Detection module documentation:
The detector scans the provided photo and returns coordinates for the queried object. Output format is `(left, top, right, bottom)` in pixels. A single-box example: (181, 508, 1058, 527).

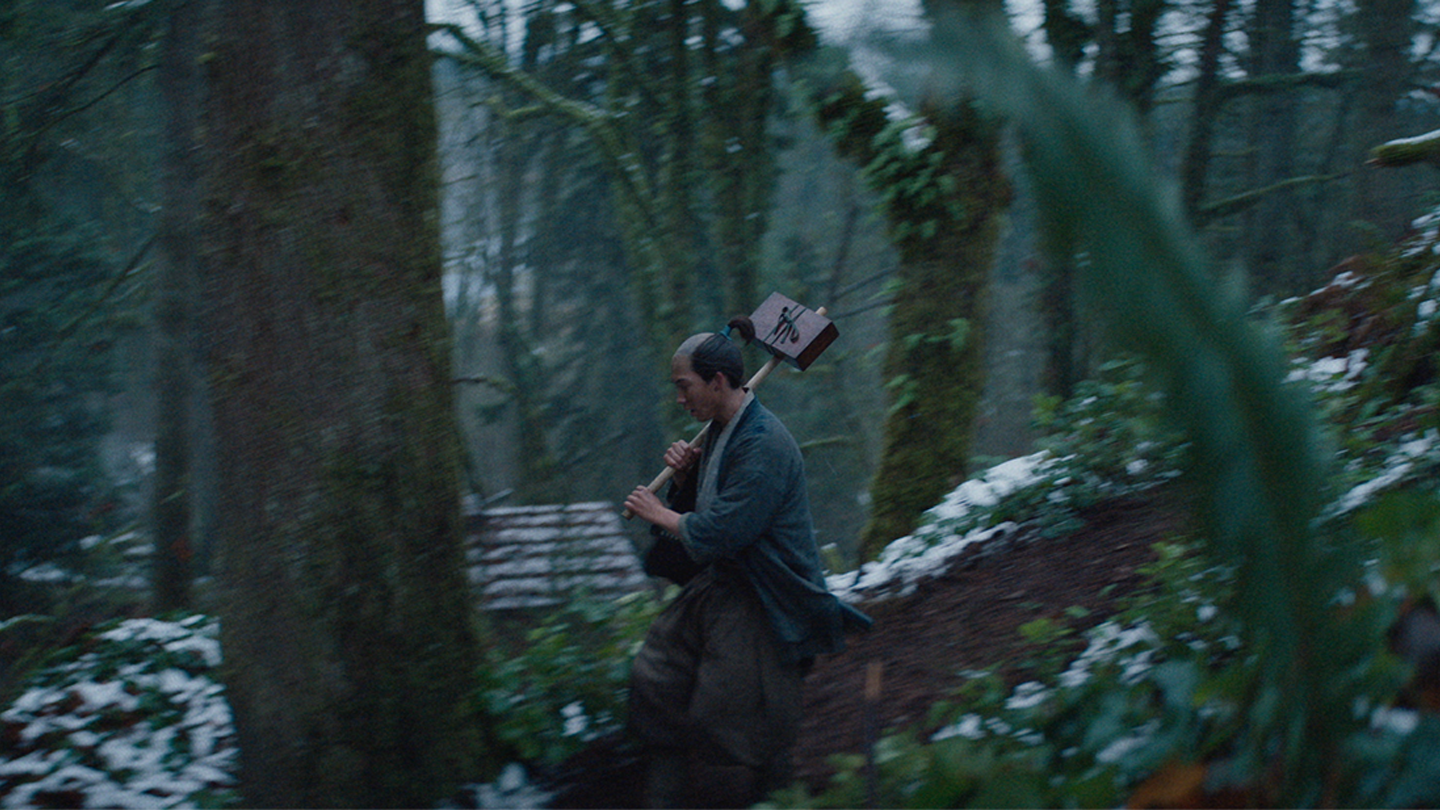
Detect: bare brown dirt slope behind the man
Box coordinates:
(541, 496, 1188, 807)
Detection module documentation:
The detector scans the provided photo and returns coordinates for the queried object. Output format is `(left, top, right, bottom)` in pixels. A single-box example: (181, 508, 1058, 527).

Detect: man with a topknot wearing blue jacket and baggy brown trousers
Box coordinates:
(625, 319, 870, 807)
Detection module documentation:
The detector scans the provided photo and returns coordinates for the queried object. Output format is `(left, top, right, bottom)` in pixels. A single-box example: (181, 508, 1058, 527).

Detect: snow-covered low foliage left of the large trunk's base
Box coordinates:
(0, 615, 236, 810)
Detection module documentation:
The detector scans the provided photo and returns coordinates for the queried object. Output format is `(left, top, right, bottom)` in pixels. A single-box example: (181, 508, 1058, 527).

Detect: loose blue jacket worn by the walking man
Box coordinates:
(665, 399, 871, 659)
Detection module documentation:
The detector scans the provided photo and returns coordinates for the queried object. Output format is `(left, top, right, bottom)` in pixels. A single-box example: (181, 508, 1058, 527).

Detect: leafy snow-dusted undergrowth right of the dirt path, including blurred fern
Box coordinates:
(775, 4, 1440, 807)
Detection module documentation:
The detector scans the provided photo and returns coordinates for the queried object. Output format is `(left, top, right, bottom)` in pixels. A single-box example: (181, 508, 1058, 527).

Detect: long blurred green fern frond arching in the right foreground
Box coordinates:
(915, 6, 1377, 804)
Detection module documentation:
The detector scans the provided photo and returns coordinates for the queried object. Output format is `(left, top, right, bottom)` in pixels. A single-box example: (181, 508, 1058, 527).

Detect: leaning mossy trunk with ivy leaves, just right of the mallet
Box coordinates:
(818, 22, 1009, 559)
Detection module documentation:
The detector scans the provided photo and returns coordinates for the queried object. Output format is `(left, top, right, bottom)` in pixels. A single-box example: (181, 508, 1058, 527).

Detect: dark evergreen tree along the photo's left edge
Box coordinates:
(0, 1, 151, 613)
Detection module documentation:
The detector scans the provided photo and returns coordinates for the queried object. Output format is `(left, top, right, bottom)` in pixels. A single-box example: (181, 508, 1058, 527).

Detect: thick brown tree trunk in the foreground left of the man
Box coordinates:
(202, 0, 482, 807)
